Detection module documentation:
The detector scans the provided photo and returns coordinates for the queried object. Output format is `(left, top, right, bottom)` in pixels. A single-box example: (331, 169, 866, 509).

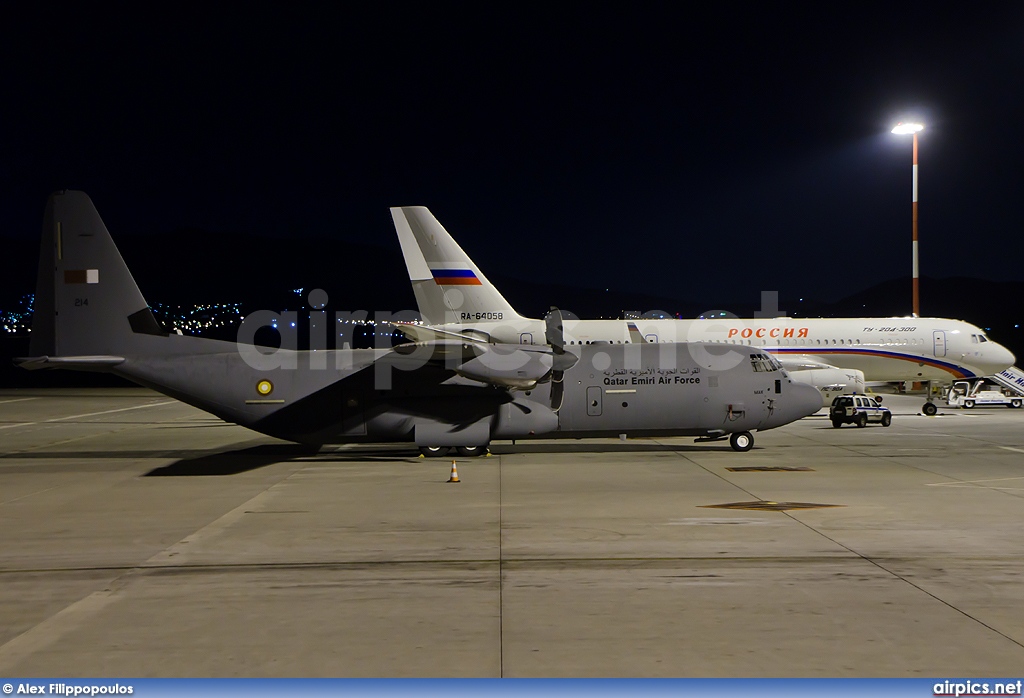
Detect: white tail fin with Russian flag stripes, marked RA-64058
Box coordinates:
(391, 206, 521, 324)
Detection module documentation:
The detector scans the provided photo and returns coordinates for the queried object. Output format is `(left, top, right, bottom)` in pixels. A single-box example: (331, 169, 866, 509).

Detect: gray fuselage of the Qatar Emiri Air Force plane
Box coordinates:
(102, 335, 821, 446)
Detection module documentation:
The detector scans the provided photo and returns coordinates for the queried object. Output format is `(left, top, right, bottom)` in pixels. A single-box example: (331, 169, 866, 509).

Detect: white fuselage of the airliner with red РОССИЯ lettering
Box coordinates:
(425, 317, 1015, 383)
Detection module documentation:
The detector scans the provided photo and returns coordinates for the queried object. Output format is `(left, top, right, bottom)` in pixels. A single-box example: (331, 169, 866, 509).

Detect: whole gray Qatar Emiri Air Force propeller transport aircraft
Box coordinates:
(15, 191, 821, 455)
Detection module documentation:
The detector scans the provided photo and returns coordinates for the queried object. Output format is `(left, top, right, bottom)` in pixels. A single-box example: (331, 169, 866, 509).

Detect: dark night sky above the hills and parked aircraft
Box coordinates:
(6, 3, 1024, 304)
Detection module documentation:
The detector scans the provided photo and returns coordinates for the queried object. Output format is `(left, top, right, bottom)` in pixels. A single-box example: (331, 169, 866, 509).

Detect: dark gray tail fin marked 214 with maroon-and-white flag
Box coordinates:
(30, 190, 165, 356)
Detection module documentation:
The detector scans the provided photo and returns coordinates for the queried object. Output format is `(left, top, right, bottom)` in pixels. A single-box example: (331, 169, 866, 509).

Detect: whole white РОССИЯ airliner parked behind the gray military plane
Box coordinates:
(391, 206, 1014, 415)
